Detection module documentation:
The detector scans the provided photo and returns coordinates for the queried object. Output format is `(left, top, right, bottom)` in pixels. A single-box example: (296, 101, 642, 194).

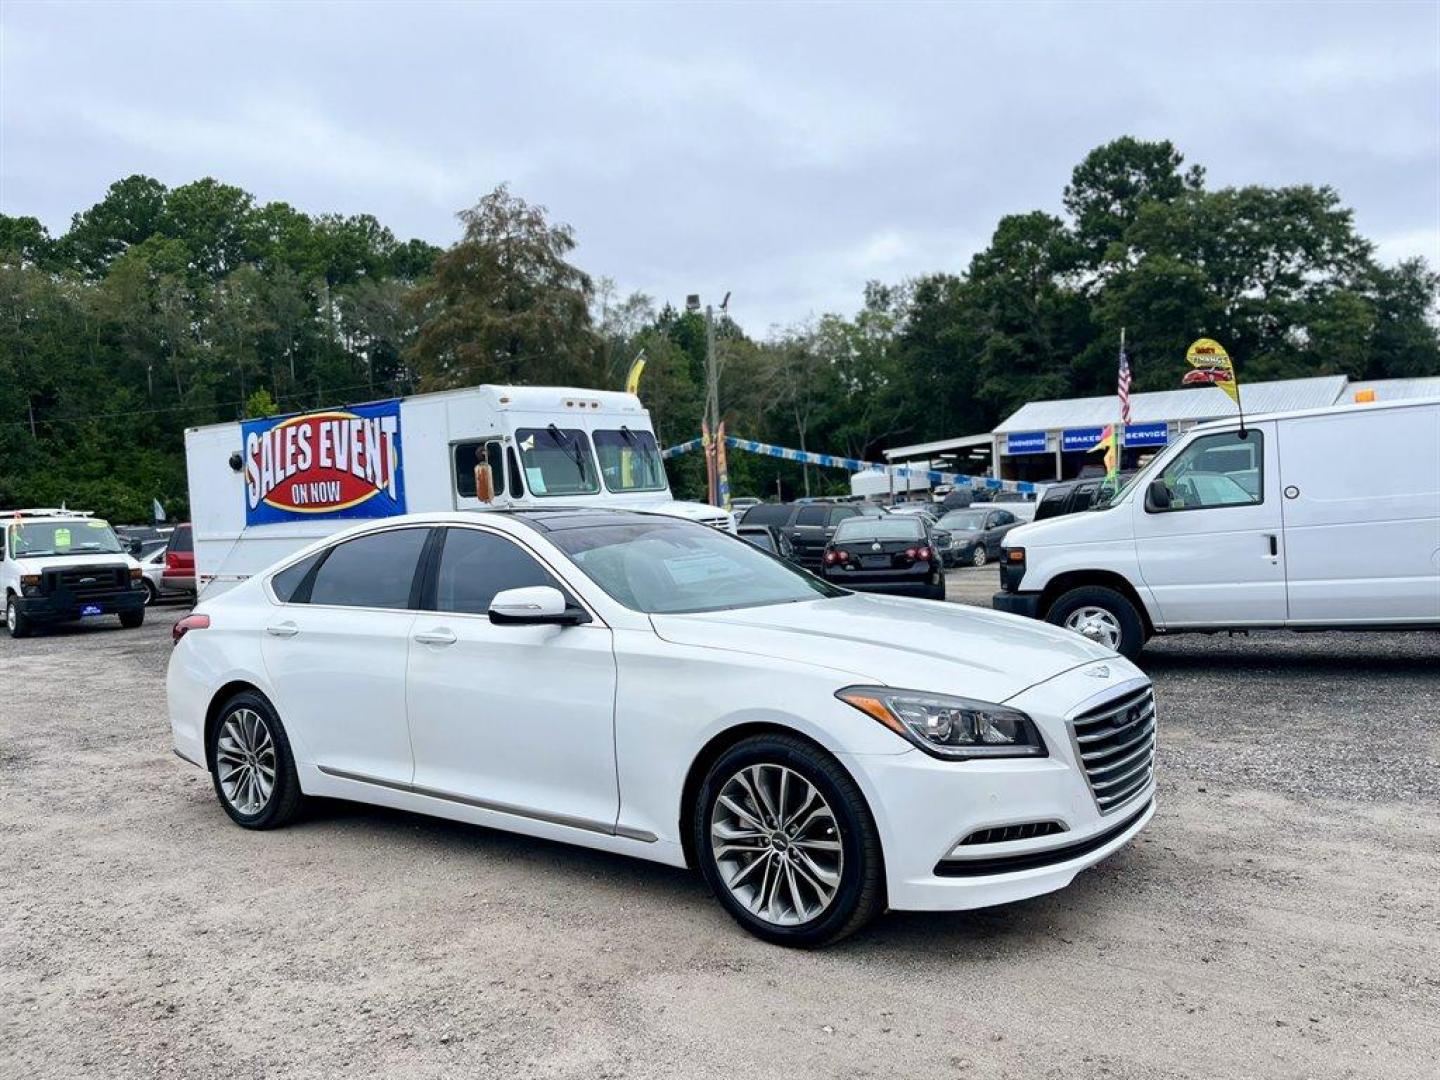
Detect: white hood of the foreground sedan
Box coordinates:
(651, 593, 1115, 701)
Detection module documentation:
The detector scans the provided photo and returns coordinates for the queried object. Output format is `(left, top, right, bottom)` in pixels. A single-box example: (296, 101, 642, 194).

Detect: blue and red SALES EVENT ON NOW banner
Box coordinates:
(240, 400, 405, 526)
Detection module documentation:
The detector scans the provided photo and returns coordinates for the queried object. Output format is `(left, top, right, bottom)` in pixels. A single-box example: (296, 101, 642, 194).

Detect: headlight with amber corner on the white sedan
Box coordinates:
(835, 687, 1045, 760)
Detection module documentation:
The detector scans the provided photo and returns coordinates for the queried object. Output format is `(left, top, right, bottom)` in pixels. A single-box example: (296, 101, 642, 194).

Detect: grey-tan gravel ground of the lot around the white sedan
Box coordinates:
(0, 570, 1440, 1080)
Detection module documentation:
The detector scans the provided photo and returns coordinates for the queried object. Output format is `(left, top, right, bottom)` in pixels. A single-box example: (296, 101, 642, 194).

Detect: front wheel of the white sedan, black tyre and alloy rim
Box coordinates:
(693, 734, 884, 948)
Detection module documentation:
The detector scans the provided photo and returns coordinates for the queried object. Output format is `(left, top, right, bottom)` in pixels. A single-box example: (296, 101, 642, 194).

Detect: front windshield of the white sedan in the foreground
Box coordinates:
(549, 521, 845, 615)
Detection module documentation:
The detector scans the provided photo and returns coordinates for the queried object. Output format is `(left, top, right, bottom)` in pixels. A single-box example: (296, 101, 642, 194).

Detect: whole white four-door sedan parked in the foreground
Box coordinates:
(168, 510, 1156, 945)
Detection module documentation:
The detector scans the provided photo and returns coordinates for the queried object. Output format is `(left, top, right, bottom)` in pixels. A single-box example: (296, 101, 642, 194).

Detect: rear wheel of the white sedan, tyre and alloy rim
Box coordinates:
(207, 691, 304, 829)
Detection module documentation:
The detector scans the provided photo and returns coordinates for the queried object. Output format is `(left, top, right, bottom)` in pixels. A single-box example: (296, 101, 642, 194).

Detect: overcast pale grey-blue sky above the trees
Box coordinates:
(0, 0, 1440, 334)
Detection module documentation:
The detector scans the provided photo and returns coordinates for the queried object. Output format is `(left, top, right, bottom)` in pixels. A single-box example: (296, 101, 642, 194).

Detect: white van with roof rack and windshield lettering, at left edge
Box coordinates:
(0, 510, 145, 638)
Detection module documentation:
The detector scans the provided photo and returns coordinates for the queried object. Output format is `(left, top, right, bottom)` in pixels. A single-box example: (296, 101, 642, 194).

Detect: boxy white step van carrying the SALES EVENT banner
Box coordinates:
(186, 386, 734, 598)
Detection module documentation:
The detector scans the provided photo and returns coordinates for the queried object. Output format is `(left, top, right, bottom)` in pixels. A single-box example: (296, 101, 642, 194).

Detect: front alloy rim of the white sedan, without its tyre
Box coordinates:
(710, 765, 844, 926)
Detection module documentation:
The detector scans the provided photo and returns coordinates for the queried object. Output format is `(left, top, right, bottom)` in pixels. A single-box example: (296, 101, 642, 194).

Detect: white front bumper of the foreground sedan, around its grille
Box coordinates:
(844, 661, 1155, 912)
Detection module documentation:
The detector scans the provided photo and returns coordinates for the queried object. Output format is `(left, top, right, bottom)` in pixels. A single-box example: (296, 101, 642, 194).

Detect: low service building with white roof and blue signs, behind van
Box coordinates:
(886, 374, 1440, 482)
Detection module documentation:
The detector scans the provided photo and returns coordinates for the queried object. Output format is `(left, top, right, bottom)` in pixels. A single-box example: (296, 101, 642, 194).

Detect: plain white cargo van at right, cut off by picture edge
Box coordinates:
(994, 399, 1440, 657)
